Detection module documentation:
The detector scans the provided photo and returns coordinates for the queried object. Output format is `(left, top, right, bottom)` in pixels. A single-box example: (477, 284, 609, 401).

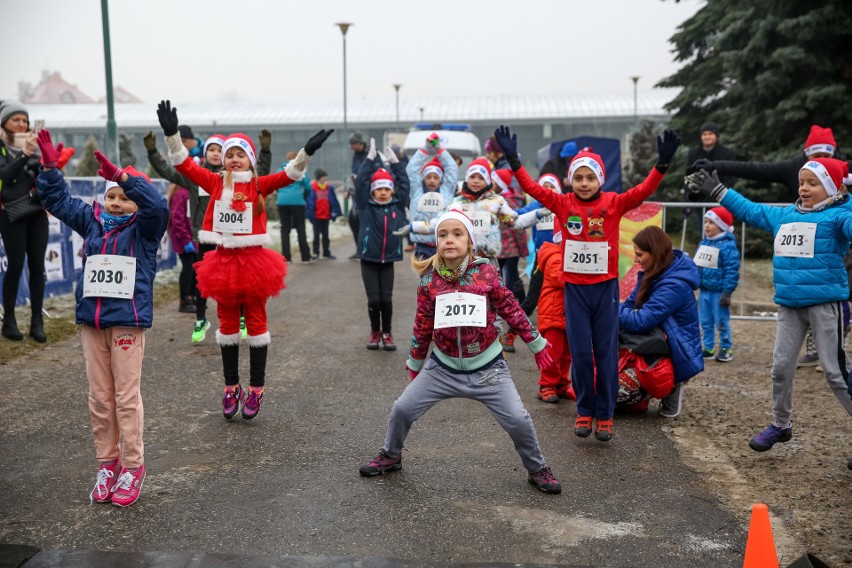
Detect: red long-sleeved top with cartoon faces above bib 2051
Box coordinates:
(515, 166, 663, 284)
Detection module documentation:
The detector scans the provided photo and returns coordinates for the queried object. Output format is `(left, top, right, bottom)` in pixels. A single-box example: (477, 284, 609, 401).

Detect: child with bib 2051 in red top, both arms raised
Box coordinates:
(494, 126, 680, 442)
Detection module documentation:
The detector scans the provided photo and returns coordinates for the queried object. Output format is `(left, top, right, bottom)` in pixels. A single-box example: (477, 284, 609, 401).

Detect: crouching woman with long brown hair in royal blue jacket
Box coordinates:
(618, 226, 704, 418)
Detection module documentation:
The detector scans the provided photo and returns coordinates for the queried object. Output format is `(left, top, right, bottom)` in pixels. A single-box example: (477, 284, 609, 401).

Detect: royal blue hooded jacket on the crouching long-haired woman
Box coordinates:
(618, 249, 704, 384)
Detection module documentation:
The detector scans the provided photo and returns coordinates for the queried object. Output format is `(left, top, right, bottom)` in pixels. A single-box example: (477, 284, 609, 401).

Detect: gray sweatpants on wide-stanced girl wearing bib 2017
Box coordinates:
(383, 357, 545, 472)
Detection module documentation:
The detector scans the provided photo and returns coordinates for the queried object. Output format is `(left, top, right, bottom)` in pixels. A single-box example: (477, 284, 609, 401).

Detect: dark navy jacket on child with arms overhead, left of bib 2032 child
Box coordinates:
(355, 156, 408, 263)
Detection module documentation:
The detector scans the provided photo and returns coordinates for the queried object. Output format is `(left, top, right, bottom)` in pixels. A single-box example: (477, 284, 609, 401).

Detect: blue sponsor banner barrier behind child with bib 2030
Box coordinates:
(0, 177, 177, 306)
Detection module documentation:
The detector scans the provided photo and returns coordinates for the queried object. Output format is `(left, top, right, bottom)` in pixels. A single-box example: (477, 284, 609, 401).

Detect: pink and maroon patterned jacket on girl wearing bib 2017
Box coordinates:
(407, 258, 547, 371)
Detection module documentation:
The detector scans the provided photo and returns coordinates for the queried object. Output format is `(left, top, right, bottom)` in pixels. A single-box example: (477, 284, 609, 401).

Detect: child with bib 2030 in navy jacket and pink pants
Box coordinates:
(36, 130, 169, 507)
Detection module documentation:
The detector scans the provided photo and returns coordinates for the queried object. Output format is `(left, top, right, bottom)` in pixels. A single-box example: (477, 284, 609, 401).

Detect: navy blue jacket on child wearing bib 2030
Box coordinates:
(36, 169, 169, 329)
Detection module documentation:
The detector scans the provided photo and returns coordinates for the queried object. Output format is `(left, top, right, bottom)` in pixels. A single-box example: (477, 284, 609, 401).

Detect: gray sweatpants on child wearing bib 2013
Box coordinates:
(772, 302, 852, 428)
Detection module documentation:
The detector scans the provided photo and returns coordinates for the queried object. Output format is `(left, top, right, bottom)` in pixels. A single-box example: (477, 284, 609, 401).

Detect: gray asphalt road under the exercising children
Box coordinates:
(0, 240, 747, 567)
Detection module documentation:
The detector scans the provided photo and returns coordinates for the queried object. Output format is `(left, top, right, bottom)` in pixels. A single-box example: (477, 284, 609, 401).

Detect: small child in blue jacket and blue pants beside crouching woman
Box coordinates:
(693, 207, 740, 363)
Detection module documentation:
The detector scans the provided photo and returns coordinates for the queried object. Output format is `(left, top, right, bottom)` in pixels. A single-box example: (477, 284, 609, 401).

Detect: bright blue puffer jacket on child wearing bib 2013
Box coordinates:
(722, 189, 852, 308)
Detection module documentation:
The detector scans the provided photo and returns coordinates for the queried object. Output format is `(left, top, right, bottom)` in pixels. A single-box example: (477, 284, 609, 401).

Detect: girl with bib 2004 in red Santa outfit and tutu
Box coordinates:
(157, 101, 334, 420)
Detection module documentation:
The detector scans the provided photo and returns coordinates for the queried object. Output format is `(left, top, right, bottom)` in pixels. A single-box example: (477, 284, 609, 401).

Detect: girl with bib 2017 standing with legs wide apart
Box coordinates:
(360, 211, 562, 493)
